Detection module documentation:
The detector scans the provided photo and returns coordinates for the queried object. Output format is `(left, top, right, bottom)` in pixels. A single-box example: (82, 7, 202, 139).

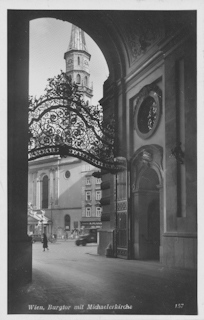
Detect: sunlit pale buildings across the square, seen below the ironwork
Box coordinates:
(28, 156, 101, 238)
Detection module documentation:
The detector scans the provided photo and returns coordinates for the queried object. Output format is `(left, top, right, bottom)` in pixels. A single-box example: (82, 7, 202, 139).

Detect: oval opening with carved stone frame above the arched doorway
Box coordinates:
(134, 85, 161, 139)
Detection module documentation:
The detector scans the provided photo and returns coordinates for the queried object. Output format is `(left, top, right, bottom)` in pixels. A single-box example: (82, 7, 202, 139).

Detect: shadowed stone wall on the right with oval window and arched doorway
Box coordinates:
(98, 12, 197, 269)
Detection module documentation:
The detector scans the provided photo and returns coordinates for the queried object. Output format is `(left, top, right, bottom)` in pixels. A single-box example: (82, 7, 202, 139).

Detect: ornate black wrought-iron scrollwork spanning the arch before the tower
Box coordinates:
(28, 72, 122, 172)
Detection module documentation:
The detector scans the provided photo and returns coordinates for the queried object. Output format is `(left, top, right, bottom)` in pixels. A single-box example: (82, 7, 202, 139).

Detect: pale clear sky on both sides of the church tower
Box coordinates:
(29, 18, 109, 105)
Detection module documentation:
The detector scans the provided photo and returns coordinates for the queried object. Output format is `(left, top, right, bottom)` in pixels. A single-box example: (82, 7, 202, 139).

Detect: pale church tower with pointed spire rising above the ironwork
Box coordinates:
(64, 25, 93, 104)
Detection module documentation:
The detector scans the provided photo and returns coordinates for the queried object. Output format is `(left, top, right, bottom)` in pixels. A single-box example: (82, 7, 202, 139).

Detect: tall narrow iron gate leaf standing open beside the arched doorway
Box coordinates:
(115, 157, 129, 259)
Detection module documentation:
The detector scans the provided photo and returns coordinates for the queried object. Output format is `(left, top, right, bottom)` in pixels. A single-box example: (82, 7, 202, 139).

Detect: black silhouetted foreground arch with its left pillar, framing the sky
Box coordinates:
(8, 10, 125, 288)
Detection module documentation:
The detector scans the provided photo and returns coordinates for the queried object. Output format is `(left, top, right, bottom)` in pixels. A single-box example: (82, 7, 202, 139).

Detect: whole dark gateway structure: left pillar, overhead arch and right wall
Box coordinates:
(8, 10, 197, 292)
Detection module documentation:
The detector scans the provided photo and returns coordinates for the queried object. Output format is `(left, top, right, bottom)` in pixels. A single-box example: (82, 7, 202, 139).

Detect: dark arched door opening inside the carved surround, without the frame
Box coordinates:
(132, 166, 160, 261)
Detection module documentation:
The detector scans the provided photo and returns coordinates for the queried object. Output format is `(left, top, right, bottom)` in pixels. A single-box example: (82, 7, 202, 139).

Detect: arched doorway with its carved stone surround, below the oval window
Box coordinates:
(131, 145, 163, 261)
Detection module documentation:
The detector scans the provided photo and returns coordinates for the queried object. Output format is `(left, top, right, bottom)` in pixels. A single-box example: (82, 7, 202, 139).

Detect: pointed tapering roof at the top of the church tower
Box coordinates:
(68, 24, 88, 52)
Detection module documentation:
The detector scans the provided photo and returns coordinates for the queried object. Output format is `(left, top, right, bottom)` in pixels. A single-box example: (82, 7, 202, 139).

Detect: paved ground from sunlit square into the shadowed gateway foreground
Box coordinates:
(9, 240, 197, 315)
